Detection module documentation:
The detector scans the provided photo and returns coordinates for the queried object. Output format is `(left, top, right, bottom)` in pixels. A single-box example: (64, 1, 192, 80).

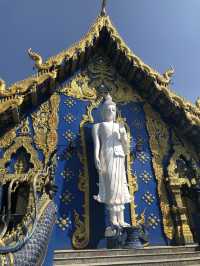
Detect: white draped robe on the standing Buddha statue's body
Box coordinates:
(96, 122, 131, 211)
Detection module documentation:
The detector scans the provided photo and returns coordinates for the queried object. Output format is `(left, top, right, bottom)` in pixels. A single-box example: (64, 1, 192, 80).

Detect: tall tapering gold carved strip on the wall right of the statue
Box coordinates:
(144, 103, 174, 239)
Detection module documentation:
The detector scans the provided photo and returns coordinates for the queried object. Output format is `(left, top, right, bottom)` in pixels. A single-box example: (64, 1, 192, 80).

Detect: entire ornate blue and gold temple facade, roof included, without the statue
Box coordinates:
(0, 4, 200, 266)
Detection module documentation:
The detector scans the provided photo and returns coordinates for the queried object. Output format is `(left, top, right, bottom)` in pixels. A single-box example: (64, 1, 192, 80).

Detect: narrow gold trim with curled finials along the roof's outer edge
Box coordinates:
(0, 16, 200, 135)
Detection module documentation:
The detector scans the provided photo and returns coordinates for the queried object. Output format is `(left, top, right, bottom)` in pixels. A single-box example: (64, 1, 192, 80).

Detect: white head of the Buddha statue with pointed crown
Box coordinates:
(102, 94, 117, 122)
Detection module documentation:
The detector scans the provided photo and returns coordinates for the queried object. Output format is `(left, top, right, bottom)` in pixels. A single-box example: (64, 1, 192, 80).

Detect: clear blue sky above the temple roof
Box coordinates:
(0, 0, 200, 102)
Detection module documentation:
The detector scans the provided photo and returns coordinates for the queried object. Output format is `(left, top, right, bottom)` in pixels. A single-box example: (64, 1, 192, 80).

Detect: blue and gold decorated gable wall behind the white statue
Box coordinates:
(0, 55, 198, 265)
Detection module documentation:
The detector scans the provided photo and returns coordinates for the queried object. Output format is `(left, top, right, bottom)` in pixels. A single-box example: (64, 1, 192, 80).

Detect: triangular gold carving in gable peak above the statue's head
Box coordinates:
(60, 55, 142, 103)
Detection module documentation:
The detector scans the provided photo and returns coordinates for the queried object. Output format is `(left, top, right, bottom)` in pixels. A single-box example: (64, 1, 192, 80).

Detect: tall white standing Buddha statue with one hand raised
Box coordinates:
(93, 94, 131, 227)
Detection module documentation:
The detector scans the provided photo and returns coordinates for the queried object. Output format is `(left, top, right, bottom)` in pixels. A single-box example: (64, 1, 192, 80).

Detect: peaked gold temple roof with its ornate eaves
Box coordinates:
(0, 15, 200, 141)
